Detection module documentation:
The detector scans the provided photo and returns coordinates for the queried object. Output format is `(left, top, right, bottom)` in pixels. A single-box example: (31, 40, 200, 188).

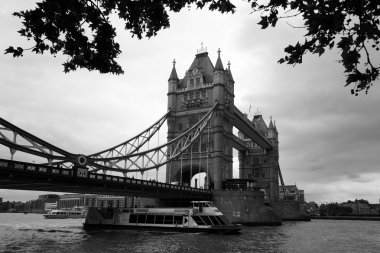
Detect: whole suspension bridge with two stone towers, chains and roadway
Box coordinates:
(0, 46, 296, 223)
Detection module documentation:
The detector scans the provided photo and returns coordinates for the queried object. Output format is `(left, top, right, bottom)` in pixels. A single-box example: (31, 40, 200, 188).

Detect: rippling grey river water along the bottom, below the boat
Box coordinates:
(0, 213, 380, 253)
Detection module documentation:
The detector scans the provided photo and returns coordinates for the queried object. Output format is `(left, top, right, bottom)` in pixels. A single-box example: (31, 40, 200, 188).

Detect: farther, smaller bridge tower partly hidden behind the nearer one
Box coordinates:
(239, 111, 280, 202)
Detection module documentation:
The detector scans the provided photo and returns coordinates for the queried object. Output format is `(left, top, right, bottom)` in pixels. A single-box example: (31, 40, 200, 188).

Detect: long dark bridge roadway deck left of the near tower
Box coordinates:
(0, 159, 212, 200)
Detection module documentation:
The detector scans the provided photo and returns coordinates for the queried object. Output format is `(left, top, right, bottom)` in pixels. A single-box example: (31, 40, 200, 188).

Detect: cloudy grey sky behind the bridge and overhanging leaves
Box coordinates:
(0, 0, 380, 203)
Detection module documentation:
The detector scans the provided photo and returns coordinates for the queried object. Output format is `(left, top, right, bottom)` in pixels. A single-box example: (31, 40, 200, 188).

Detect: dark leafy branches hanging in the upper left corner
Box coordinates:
(5, 0, 234, 74)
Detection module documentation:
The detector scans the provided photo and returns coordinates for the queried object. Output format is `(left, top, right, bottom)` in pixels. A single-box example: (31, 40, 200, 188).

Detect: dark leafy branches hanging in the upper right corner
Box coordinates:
(251, 0, 380, 95)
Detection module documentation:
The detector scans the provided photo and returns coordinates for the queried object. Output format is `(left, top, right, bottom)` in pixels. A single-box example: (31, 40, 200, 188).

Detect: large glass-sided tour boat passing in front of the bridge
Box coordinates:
(84, 201, 241, 234)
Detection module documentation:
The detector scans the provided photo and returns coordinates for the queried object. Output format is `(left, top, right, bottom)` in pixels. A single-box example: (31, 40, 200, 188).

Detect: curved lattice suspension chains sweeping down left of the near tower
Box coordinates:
(0, 104, 217, 177)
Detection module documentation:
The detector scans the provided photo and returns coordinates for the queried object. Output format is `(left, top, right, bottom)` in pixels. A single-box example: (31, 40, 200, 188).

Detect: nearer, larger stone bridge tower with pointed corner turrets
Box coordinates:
(166, 45, 234, 190)
